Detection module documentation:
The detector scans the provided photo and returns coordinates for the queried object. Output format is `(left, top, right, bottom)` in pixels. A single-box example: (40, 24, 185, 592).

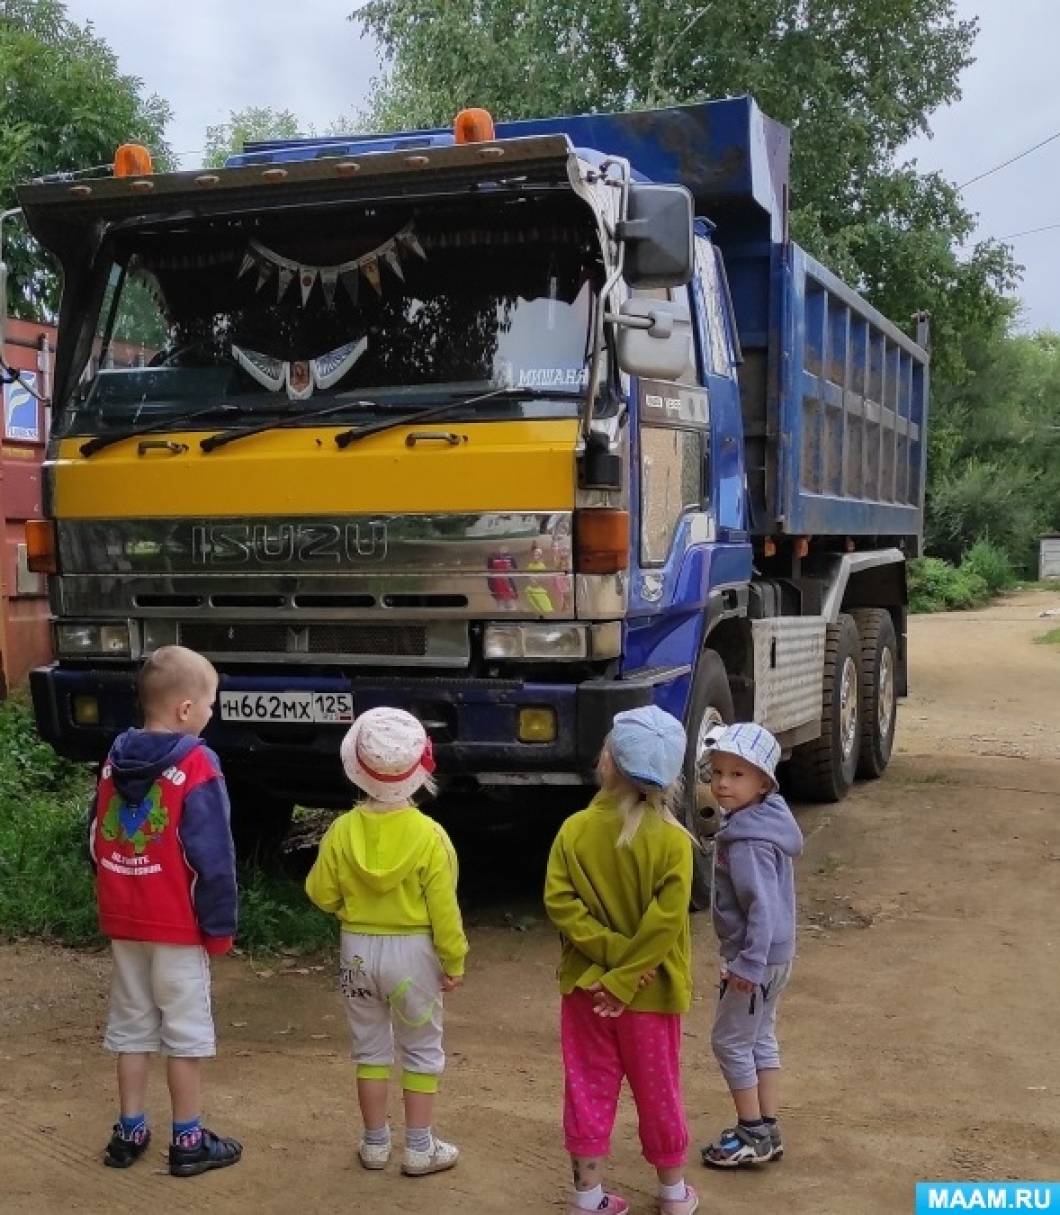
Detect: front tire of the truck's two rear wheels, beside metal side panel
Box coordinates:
(788, 612, 861, 802)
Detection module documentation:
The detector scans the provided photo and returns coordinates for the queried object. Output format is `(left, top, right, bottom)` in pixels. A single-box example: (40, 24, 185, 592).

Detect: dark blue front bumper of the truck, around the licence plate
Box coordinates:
(30, 663, 687, 804)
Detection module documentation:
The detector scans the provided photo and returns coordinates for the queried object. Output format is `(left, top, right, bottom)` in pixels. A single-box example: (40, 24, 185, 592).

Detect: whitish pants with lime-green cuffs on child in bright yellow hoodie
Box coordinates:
(339, 932, 445, 1092)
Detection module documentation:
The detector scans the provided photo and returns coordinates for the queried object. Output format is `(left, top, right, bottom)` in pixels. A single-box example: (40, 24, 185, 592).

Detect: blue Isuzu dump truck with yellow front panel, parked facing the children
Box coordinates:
(21, 97, 928, 897)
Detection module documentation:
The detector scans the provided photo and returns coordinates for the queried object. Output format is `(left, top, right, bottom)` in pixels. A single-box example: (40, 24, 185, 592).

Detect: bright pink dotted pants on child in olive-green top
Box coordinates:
(560, 991, 688, 1169)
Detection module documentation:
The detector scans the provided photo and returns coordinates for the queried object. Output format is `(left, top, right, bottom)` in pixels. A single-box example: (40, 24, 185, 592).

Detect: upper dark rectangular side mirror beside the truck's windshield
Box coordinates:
(618, 181, 693, 288)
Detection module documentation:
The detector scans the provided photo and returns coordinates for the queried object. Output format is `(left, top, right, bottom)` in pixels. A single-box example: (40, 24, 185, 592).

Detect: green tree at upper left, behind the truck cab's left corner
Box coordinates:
(0, 0, 170, 317)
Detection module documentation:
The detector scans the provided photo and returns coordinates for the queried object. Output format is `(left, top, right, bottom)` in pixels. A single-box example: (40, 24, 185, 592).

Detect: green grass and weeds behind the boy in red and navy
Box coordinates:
(0, 700, 338, 954)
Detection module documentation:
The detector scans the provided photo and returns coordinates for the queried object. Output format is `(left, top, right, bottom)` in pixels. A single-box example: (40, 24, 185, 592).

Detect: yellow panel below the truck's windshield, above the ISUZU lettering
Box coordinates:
(52, 419, 577, 519)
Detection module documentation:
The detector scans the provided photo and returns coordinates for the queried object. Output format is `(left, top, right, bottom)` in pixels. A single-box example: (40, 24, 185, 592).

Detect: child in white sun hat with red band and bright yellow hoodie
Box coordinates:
(305, 708, 468, 1176)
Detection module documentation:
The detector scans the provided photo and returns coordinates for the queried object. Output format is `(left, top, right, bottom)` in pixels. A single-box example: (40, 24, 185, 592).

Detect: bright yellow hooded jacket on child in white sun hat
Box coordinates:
(305, 806, 468, 977)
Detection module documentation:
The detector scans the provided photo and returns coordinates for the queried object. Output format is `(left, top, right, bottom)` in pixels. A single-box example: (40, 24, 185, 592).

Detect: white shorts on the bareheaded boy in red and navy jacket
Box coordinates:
(103, 940, 218, 1058)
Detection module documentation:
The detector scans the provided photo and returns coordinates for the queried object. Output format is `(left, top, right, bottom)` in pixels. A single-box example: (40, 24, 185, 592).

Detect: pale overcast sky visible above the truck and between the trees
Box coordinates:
(67, 0, 1060, 329)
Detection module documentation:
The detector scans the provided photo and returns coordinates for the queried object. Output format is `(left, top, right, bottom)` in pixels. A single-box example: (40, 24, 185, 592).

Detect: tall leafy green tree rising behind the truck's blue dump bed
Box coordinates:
(350, 0, 1016, 379)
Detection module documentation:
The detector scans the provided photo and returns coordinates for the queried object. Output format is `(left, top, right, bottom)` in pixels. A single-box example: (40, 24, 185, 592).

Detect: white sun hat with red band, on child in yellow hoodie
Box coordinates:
(339, 708, 434, 806)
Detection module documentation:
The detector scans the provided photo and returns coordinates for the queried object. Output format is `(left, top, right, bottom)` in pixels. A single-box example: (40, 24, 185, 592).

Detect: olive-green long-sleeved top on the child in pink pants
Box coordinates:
(545, 793, 692, 1012)
